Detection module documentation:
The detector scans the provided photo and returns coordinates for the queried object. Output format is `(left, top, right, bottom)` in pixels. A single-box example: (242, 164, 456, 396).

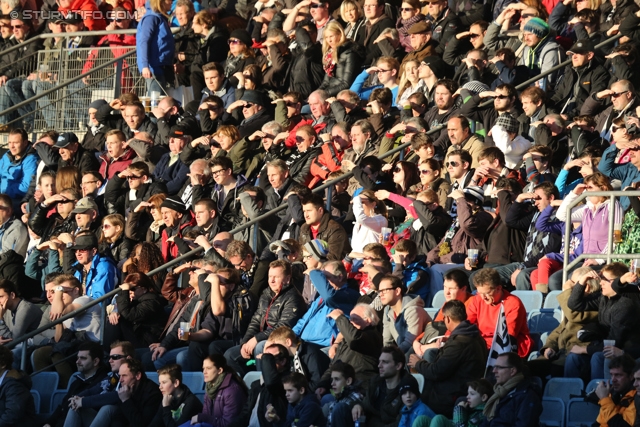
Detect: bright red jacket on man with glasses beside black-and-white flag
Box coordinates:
(466, 289, 533, 357)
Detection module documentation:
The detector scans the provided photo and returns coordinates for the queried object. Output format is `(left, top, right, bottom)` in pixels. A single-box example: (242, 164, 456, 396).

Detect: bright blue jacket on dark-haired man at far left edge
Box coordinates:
(0, 149, 38, 205)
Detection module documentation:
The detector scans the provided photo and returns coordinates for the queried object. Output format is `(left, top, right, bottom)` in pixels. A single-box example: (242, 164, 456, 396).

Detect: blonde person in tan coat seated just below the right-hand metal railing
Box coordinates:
(528, 267, 600, 378)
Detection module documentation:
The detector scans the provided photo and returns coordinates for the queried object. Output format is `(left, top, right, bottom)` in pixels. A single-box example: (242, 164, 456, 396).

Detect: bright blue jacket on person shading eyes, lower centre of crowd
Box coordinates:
(293, 270, 360, 347)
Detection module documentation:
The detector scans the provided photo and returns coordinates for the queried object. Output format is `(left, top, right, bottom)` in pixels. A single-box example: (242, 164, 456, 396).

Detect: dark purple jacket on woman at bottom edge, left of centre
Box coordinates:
(198, 374, 247, 427)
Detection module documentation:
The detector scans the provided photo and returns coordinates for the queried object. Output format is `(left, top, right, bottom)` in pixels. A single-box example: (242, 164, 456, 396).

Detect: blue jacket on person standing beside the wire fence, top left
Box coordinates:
(136, 1, 176, 76)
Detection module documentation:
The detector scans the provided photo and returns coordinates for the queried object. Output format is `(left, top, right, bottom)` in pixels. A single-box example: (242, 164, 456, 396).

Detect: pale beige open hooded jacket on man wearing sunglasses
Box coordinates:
(382, 295, 431, 353)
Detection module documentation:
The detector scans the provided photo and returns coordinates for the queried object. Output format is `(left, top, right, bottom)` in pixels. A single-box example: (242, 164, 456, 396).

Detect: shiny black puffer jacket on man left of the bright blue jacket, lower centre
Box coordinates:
(242, 284, 307, 344)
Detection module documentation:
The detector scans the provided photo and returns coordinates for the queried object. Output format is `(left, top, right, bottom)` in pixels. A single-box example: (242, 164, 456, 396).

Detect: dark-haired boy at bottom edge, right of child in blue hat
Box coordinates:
(415, 378, 493, 427)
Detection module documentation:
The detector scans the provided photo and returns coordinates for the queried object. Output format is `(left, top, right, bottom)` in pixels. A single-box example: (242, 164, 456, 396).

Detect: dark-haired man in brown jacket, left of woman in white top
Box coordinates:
(298, 194, 349, 260)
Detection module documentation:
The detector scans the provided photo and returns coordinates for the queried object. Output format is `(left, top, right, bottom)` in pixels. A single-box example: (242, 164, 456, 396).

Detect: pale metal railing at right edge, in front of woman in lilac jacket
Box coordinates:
(562, 191, 640, 283)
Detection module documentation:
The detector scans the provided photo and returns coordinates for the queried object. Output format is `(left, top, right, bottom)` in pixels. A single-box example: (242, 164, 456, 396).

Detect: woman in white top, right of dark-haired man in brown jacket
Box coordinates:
(351, 190, 388, 254)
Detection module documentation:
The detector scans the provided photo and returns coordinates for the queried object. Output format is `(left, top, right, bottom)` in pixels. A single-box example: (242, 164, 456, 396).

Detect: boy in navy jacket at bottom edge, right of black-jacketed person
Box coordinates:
(265, 372, 326, 427)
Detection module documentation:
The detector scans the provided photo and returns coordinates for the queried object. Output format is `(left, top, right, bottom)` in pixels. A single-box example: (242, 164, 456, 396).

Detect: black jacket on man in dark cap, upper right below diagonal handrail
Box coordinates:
(552, 61, 609, 119)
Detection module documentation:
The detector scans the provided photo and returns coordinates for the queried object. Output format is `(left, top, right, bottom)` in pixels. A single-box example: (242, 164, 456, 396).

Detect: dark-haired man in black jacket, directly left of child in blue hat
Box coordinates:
(351, 346, 411, 427)
